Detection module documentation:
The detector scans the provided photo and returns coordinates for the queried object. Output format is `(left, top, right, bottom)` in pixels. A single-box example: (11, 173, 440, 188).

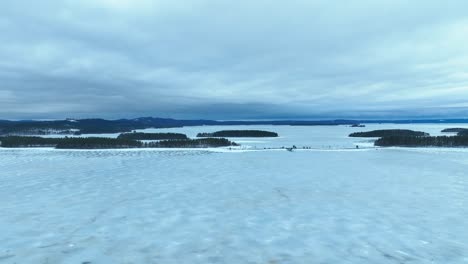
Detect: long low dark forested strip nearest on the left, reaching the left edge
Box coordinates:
(0, 136, 238, 149)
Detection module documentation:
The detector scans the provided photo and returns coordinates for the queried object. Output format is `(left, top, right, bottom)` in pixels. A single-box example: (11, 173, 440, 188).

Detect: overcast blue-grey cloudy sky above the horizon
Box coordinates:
(0, 0, 468, 119)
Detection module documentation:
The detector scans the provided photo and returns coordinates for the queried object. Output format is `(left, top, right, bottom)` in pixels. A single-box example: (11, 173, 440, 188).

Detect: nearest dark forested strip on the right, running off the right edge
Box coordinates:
(375, 136, 468, 147)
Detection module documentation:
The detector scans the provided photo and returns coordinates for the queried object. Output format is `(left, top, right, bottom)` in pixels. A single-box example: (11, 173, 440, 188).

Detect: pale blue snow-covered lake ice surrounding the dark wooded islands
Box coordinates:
(0, 125, 468, 264)
